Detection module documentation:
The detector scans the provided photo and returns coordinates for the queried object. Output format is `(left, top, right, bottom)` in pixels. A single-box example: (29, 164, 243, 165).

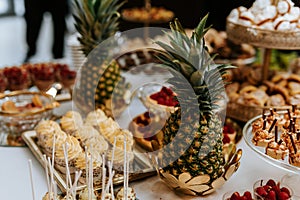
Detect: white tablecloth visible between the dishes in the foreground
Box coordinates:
(0, 102, 296, 200)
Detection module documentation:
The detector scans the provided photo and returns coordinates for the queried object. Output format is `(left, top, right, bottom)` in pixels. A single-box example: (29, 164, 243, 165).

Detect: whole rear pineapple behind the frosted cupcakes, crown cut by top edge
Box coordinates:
(73, 0, 129, 116)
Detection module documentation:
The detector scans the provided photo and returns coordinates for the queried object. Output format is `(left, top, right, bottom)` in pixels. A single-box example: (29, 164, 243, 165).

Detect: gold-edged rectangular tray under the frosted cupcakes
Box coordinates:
(22, 131, 156, 192)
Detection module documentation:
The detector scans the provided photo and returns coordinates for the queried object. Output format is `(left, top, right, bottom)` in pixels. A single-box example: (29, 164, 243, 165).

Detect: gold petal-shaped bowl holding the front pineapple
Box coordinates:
(151, 144, 242, 196)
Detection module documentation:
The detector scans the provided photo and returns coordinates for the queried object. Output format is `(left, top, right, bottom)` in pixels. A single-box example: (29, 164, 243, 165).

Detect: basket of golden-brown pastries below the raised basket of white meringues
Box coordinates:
(226, 66, 300, 122)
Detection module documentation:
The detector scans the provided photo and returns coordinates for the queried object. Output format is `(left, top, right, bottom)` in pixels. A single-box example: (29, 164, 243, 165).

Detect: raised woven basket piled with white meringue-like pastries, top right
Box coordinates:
(226, 0, 300, 49)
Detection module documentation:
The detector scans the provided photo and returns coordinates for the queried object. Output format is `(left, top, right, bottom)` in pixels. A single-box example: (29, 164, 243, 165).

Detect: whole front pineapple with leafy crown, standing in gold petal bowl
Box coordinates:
(152, 16, 232, 194)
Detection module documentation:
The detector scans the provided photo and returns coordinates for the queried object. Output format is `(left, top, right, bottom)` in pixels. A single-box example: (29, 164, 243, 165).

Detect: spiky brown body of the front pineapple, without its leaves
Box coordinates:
(161, 108, 224, 182)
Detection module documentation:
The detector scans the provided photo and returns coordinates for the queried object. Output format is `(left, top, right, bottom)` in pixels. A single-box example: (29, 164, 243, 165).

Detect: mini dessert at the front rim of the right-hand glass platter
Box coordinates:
(266, 140, 289, 160)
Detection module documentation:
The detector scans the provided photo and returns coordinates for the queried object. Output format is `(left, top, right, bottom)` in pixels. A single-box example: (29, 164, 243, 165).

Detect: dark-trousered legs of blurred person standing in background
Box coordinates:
(24, 0, 69, 62)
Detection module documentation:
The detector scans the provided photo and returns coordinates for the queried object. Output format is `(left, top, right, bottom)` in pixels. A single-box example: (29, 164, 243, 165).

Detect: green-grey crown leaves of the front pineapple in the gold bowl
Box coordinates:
(150, 15, 233, 115)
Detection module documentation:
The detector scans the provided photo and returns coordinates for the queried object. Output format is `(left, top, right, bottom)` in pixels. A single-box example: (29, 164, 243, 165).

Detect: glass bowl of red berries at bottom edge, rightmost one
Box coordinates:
(253, 179, 294, 200)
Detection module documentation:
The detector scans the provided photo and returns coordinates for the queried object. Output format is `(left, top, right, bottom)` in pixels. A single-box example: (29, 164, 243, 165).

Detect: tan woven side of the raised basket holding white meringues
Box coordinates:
(226, 20, 300, 50)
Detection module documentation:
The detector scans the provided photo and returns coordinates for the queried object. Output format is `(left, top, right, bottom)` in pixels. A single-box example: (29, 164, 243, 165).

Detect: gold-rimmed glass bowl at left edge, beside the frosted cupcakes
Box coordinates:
(0, 91, 59, 146)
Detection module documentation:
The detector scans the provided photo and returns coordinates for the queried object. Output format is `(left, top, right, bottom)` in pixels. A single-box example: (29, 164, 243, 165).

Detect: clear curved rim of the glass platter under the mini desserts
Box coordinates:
(243, 115, 300, 174)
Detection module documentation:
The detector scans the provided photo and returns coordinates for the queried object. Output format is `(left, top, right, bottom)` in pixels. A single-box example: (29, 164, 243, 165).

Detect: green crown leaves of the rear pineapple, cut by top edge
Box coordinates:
(73, 0, 125, 56)
